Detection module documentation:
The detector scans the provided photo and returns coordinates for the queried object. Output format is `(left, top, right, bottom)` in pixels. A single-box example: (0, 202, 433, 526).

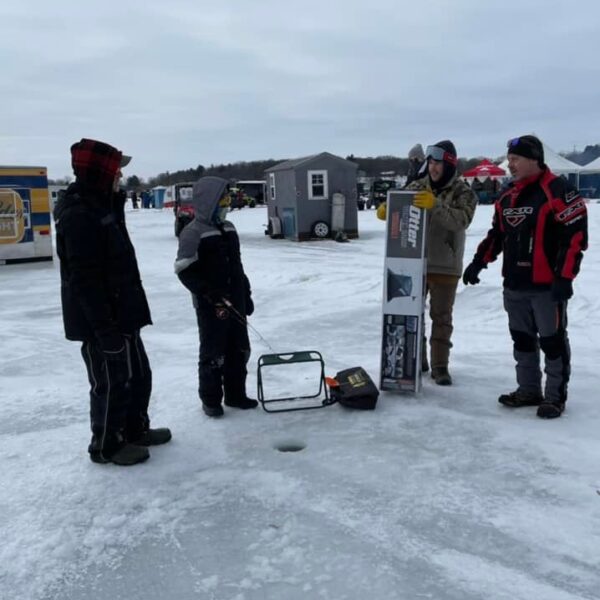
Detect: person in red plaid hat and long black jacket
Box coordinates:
(54, 138, 171, 465)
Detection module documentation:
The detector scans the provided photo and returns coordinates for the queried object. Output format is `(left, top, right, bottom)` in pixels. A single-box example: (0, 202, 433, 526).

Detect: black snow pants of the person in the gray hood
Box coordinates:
(196, 306, 250, 406)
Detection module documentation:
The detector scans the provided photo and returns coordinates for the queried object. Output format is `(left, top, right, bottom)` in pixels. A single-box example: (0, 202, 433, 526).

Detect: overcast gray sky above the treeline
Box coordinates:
(0, 0, 600, 178)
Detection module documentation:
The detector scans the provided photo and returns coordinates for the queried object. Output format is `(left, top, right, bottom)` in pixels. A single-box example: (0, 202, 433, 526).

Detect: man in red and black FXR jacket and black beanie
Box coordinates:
(463, 135, 587, 419)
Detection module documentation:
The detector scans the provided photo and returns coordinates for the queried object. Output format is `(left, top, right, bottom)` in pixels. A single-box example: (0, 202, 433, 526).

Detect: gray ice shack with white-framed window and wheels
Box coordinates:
(265, 152, 358, 241)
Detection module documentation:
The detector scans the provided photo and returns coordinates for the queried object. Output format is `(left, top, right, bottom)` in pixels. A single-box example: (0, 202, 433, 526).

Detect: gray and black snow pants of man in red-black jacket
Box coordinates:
(504, 288, 571, 402)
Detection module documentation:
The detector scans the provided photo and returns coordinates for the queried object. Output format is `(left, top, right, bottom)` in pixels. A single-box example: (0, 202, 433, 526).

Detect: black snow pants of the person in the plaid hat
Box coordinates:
(81, 331, 152, 450)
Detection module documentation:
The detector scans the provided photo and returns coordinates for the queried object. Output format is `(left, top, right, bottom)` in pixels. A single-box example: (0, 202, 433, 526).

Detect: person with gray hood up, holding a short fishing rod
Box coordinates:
(175, 177, 258, 417)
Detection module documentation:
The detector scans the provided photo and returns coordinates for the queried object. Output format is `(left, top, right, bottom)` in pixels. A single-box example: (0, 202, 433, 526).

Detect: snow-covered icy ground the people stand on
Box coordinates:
(0, 204, 600, 600)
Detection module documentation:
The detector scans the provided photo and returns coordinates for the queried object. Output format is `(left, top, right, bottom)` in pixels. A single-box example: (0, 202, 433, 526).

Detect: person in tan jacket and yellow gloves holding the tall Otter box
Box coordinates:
(377, 140, 477, 385)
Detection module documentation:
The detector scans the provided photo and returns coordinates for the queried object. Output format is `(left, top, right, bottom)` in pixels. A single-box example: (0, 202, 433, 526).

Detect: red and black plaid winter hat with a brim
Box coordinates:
(71, 138, 131, 191)
